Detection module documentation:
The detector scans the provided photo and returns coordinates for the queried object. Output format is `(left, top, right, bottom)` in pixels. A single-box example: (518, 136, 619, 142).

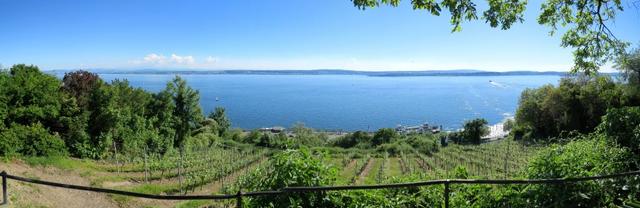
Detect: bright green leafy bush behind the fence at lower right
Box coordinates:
(521, 134, 638, 207)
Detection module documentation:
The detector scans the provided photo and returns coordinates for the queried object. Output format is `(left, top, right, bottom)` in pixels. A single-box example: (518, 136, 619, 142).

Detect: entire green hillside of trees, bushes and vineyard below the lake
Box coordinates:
(0, 57, 640, 207)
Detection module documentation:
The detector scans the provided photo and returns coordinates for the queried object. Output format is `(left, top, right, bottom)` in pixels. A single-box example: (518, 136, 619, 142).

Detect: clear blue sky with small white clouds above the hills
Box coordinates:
(0, 0, 640, 71)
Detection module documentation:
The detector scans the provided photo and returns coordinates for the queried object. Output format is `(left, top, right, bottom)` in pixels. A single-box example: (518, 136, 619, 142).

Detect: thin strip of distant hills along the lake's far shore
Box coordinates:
(49, 69, 600, 77)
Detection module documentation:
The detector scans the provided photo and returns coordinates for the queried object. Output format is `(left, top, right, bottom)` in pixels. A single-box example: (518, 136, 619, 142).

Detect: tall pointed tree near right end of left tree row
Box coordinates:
(167, 76, 202, 147)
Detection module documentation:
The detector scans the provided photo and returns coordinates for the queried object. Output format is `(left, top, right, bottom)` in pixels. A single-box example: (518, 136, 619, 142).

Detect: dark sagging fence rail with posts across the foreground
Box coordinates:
(0, 170, 640, 207)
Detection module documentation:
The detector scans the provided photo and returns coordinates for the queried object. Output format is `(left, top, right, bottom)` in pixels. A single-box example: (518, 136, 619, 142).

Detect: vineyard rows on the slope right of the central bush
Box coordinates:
(330, 141, 538, 185)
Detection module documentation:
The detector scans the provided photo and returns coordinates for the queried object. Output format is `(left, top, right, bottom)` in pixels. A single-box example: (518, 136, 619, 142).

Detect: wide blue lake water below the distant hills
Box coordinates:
(90, 74, 561, 131)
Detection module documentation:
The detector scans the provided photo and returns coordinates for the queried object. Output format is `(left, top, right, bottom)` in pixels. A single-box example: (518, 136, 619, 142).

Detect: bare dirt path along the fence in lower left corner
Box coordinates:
(0, 161, 118, 208)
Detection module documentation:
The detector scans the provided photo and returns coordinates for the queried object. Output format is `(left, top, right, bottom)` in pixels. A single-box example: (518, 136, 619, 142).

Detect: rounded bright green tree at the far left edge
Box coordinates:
(0, 64, 65, 156)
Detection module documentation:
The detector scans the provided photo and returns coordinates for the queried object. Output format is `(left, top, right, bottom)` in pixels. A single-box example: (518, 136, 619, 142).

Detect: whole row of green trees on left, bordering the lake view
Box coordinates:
(0, 64, 215, 159)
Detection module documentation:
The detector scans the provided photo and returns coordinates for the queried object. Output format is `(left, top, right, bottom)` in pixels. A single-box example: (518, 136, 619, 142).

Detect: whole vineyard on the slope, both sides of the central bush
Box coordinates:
(80, 140, 538, 207)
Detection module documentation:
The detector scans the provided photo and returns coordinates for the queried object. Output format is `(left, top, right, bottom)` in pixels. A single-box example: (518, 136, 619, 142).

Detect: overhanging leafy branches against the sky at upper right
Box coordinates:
(351, 0, 629, 74)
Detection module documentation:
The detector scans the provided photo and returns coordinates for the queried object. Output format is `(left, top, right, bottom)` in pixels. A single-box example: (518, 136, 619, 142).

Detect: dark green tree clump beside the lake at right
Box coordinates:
(513, 76, 637, 139)
